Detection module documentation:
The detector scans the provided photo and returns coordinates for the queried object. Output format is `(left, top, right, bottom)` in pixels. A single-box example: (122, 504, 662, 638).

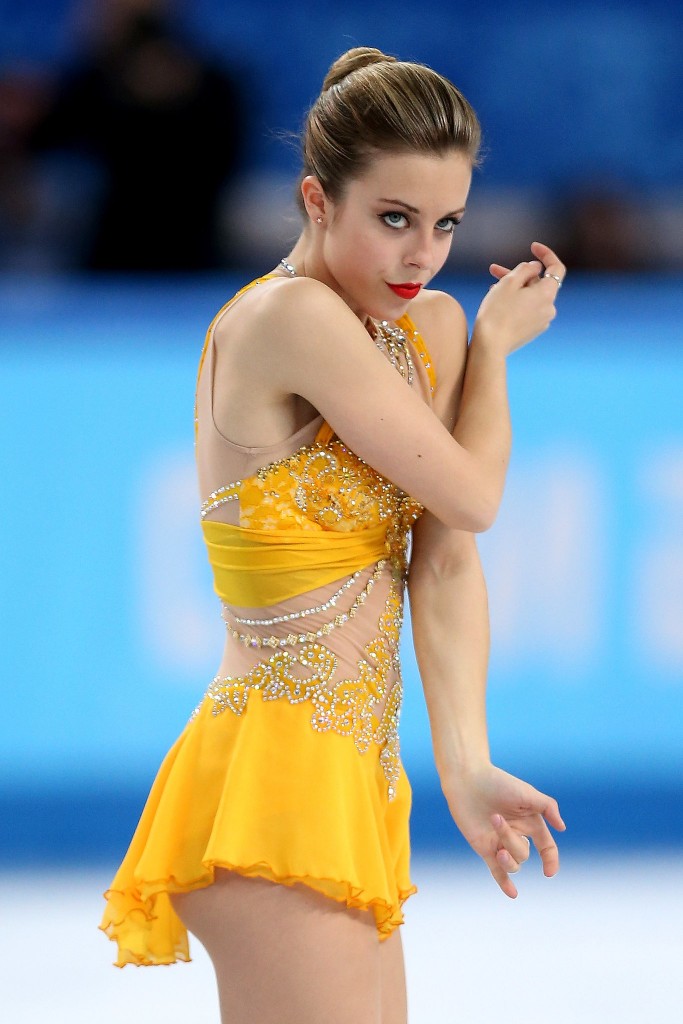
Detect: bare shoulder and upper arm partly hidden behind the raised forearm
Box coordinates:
(411, 289, 468, 425)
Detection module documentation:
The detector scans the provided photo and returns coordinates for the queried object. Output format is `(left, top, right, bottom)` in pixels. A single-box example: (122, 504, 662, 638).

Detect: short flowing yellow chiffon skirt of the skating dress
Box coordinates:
(100, 692, 416, 967)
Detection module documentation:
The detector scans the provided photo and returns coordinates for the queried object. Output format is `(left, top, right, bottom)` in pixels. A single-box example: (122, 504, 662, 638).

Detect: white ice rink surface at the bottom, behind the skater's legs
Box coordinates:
(0, 853, 683, 1024)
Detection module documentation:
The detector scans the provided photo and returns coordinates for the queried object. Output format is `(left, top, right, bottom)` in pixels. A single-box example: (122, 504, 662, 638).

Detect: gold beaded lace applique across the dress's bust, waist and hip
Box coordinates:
(198, 439, 422, 800)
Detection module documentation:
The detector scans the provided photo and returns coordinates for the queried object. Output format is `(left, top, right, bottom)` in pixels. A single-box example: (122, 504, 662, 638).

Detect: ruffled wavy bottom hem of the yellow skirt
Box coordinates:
(99, 860, 418, 968)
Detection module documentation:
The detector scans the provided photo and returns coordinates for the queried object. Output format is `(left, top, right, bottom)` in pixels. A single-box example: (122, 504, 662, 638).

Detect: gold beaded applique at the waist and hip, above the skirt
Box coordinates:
(195, 583, 402, 800)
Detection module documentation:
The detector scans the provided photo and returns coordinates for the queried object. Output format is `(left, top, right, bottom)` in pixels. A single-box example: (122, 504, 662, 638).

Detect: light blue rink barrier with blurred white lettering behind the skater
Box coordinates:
(0, 278, 683, 860)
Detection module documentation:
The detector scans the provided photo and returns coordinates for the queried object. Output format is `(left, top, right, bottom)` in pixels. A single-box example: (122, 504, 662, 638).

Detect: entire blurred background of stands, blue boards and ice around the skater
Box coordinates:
(0, 0, 683, 1024)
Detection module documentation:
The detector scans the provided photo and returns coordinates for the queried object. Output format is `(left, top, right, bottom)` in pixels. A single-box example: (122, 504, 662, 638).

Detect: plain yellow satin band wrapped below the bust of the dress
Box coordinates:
(202, 520, 387, 608)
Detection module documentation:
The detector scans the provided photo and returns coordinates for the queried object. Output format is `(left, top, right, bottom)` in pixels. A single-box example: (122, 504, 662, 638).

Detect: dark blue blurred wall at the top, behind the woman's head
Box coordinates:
(0, 0, 683, 195)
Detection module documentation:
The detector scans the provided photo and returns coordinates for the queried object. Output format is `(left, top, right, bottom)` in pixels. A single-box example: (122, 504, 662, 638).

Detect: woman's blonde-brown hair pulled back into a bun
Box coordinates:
(298, 46, 481, 210)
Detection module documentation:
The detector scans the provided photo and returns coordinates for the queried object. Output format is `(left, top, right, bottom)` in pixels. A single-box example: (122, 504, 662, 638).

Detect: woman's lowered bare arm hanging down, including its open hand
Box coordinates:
(409, 512, 564, 898)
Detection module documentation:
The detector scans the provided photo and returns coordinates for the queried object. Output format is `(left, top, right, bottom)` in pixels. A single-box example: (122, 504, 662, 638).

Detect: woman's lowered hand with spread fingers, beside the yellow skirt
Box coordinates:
(441, 764, 565, 899)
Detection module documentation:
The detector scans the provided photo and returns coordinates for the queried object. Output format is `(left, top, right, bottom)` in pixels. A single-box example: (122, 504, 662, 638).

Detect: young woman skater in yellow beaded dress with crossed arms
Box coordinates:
(102, 48, 564, 1024)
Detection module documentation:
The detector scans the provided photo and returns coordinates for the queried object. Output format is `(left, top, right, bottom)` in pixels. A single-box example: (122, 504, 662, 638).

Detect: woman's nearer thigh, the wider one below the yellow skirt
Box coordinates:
(172, 869, 385, 1024)
